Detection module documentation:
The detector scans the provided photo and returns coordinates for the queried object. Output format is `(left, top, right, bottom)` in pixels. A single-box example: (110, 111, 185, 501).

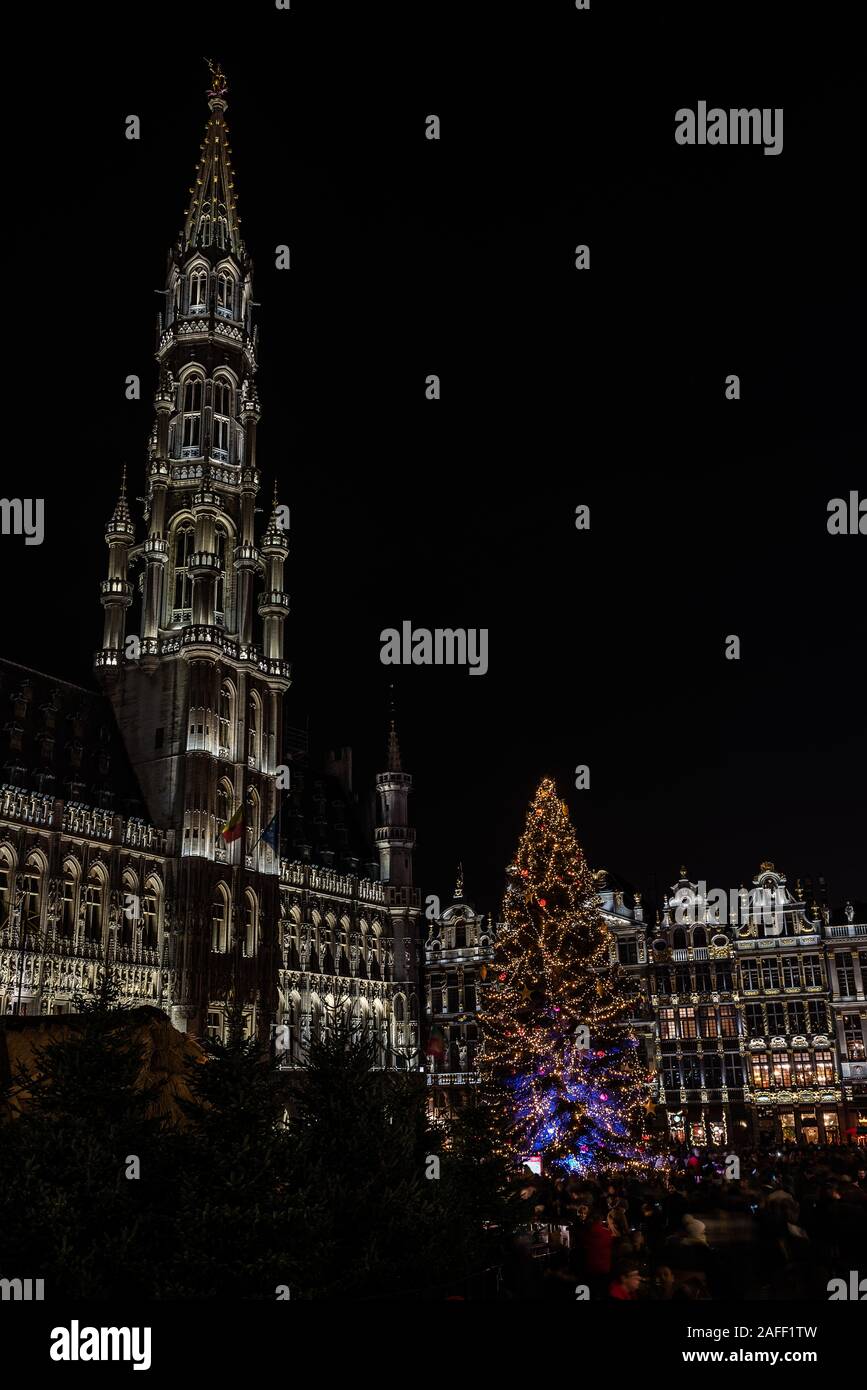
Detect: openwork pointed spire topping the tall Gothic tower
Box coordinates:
(181, 60, 243, 261)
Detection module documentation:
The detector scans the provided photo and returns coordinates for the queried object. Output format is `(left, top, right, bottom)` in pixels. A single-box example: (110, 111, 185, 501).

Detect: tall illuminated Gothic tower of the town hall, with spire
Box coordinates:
(96, 67, 290, 1034)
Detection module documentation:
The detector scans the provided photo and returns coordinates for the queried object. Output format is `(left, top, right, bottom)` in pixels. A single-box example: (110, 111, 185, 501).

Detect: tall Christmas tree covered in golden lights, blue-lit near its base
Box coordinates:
(481, 780, 647, 1172)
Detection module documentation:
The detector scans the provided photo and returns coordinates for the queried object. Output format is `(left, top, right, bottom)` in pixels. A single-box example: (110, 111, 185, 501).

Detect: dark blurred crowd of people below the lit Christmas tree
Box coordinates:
(506, 1144, 867, 1301)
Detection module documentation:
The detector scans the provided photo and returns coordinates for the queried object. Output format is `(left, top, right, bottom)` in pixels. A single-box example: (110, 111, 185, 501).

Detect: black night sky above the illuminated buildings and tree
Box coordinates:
(6, 0, 867, 909)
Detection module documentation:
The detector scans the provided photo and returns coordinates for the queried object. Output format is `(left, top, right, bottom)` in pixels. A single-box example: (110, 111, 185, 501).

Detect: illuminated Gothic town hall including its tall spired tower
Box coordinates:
(0, 68, 420, 1068)
